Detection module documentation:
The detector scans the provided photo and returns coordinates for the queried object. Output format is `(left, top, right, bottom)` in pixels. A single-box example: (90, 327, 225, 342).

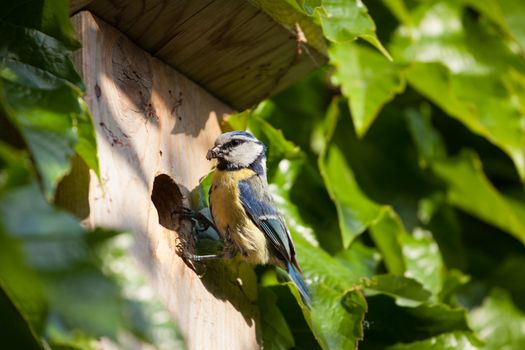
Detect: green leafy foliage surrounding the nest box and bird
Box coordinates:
(0, 0, 525, 350)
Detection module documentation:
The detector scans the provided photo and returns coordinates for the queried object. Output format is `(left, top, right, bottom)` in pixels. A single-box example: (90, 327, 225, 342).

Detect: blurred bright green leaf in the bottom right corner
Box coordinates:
(469, 288, 525, 350)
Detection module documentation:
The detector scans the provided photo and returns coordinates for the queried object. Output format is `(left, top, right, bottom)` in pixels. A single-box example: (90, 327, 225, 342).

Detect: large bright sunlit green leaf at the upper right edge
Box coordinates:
(391, 1, 525, 179)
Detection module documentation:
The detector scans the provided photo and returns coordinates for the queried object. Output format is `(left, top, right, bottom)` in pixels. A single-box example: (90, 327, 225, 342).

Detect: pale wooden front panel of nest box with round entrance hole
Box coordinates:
(73, 12, 260, 349)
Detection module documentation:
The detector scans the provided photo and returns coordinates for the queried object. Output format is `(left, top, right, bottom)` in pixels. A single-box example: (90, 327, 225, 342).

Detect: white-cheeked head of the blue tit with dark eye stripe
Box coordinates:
(206, 131, 266, 169)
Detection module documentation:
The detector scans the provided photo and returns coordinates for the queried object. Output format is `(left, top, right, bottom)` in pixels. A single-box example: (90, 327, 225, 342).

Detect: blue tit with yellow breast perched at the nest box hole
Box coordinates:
(206, 131, 311, 305)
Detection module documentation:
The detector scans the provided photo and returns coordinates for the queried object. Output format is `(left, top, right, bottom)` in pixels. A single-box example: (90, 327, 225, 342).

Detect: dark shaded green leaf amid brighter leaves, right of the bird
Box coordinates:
(340, 101, 440, 229)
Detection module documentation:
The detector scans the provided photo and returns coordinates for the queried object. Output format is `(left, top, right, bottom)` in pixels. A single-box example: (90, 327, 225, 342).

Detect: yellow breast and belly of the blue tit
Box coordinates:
(210, 169, 270, 264)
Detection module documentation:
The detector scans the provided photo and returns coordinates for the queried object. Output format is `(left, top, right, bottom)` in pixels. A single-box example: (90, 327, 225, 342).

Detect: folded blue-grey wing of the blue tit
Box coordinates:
(239, 175, 296, 264)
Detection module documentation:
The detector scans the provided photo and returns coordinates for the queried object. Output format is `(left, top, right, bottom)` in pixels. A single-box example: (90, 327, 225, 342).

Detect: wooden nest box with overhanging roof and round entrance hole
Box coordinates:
(66, 0, 326, 349)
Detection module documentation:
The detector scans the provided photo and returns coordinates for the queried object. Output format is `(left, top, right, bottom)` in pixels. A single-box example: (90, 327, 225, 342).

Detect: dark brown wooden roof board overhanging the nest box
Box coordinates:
(73, 0, 326, 109)
